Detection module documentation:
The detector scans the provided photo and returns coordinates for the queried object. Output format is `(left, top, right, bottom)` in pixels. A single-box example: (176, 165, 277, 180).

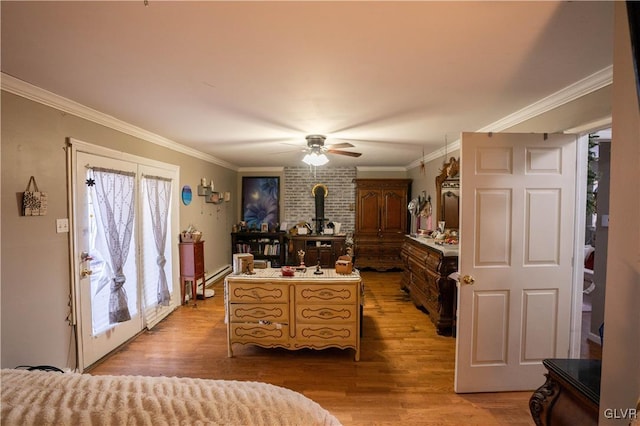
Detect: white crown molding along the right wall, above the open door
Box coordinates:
(406, 65, 613, 169)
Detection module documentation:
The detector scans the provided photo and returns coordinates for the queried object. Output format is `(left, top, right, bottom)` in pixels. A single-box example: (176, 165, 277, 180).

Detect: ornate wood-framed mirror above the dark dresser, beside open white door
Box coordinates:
(436, 157, 460, 229)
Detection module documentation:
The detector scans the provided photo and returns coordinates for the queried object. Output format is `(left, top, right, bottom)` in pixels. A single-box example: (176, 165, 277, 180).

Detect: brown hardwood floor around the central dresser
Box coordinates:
(90, 271, 532, 425)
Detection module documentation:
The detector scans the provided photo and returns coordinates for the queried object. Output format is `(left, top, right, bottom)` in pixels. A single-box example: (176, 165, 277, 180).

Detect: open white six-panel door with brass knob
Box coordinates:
(455, 133, 577, 393)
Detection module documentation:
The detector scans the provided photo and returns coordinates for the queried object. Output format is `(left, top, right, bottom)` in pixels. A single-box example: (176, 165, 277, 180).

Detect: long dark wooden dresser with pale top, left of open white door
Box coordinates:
(401, 236, 458, 335)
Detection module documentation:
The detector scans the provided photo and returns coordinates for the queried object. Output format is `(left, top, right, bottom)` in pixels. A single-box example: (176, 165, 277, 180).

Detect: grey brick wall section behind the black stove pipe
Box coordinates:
(281, 167, 356, 232)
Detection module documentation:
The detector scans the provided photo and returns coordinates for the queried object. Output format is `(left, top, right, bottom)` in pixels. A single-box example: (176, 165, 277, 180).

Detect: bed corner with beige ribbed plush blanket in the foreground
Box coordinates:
(0, 369, 340, 426)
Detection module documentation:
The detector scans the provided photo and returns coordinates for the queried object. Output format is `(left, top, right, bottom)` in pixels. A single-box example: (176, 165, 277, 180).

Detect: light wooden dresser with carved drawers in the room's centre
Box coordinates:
(224, 268, 362, 361)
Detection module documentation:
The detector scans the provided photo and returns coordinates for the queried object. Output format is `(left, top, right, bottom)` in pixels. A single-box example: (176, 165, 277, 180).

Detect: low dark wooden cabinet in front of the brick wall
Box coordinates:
(289, 235, 346, 268)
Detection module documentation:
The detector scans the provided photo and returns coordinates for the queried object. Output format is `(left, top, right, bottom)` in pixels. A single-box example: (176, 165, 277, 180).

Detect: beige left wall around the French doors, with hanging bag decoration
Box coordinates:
(0, 91, 237, 368)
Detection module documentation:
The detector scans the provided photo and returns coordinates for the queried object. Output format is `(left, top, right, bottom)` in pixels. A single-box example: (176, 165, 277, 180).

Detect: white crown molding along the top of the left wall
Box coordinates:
(0, 73, 238, 171)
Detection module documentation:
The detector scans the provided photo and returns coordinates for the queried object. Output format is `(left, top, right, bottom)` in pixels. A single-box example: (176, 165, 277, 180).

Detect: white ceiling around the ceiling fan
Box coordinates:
(1, 0, 613, 168)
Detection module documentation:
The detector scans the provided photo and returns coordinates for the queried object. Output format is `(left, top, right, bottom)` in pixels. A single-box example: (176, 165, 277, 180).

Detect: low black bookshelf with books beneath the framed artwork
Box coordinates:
(231, 232, 287, 268)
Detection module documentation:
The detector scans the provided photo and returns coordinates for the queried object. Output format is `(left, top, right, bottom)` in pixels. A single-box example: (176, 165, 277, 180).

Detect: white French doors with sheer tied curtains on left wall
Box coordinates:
(72, 142, 179, 371)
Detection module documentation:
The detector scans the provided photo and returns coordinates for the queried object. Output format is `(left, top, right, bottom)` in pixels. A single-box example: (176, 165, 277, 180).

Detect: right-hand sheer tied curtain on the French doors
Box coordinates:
(144, 175, 171, 306)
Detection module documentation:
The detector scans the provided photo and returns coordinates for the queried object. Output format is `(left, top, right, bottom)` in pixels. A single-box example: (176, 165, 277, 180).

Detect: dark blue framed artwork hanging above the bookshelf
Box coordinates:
(242, 176, 280, 230)
